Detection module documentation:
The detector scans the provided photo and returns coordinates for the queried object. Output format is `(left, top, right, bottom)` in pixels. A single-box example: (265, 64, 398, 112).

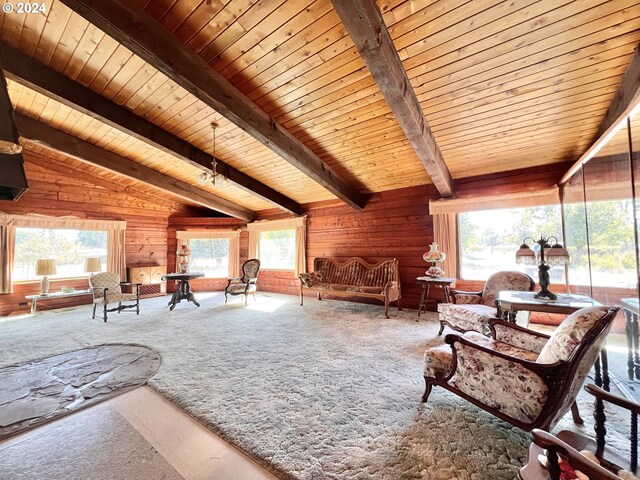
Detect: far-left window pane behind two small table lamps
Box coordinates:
(12, 227, 107, 281)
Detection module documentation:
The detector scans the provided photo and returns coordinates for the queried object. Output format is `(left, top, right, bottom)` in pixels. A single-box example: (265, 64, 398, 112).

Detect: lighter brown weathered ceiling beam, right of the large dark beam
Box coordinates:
(331, 0, 453, 197)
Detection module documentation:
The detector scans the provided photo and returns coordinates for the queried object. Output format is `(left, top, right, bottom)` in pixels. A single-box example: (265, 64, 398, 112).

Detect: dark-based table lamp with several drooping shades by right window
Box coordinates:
(516, 237, 569, 300)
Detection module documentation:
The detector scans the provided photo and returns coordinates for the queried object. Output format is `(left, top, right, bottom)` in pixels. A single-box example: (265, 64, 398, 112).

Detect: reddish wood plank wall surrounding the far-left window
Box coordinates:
(0, 150, 200, 316)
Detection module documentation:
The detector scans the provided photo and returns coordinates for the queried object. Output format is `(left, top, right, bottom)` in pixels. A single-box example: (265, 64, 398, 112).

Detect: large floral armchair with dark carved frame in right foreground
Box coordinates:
(422, 306, 619, 431)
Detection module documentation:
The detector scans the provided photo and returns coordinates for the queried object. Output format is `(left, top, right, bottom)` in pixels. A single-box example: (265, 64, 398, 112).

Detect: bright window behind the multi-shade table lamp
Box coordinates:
(458, 205, 565, 283)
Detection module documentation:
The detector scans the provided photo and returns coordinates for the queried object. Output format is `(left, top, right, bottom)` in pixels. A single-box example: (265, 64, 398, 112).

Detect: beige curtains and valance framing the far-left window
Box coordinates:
(0, 212, 127, 293)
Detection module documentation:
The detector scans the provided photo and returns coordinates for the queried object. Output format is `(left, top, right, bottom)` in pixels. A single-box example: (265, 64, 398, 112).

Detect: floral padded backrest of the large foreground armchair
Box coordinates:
(537, 307, 609, 363)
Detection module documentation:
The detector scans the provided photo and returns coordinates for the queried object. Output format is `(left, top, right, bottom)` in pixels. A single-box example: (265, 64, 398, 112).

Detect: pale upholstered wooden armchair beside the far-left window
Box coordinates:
(89, 272, 141, 322)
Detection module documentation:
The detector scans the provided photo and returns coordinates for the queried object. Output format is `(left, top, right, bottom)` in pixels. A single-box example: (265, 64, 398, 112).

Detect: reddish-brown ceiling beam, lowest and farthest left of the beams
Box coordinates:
(15, 113, 254, 221)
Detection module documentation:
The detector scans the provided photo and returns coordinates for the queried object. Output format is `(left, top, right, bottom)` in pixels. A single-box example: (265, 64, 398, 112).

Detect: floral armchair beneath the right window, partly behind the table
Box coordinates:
(438, 271, 536, 335)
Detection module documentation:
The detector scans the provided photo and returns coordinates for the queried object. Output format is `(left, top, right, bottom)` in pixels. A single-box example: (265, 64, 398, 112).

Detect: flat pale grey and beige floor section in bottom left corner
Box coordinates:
(0, 387, 276, 480)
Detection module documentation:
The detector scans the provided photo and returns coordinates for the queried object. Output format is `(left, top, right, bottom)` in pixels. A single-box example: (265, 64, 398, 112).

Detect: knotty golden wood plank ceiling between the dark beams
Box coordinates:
(0, 0, 640, 211)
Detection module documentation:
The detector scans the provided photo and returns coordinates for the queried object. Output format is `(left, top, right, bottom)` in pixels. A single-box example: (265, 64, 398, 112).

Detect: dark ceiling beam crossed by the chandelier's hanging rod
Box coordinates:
(0, 42, 301, 215)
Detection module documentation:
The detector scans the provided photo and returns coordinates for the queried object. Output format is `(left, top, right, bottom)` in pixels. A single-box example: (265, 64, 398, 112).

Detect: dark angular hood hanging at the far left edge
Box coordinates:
(0, 72, 29, 200)
